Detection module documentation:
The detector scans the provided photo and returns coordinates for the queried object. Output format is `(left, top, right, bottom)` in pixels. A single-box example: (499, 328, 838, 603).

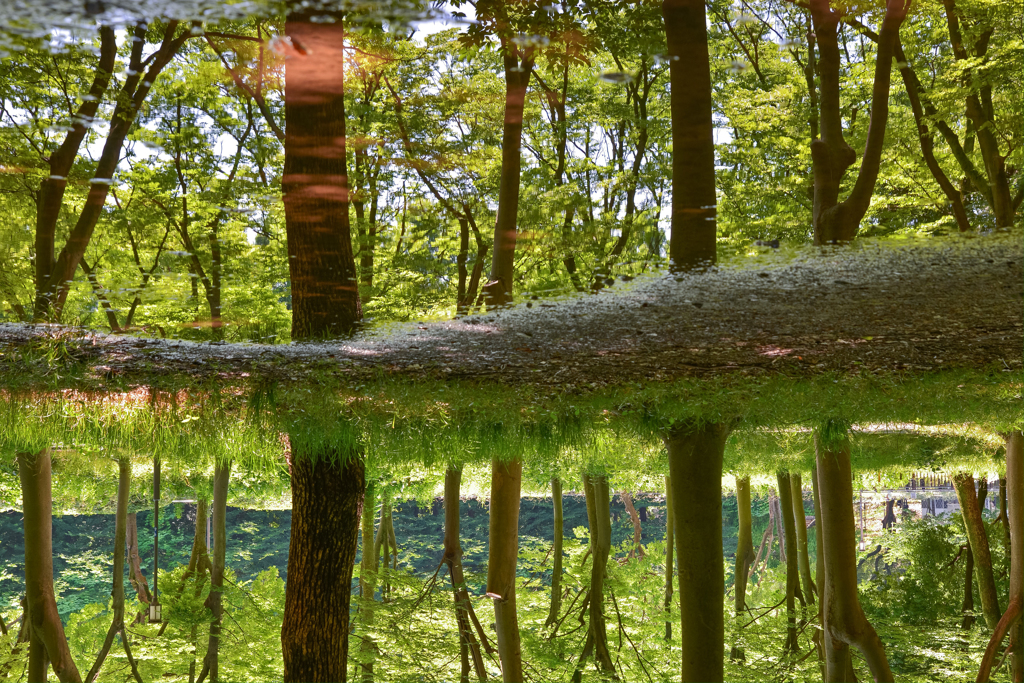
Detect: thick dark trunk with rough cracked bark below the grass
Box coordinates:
(281, 448, 366, 682)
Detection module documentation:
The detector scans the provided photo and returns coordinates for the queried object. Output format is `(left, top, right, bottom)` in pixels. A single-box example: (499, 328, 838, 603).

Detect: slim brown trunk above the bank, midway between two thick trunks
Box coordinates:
(483, 43, 534, 306)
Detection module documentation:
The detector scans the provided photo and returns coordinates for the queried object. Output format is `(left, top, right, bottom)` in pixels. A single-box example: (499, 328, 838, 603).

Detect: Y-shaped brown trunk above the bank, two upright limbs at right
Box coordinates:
(810, 0, 910, 245)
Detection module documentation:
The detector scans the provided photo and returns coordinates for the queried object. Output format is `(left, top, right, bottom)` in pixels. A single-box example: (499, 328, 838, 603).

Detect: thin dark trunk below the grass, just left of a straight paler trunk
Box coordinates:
(444, 466, 487, 683)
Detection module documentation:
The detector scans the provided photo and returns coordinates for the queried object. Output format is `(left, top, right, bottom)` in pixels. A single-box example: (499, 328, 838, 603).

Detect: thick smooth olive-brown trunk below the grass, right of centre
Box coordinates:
(663, 419, 729, 683)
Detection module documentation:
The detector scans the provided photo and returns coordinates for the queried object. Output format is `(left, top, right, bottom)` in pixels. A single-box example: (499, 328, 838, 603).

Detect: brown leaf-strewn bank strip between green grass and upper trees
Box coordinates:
(0, 233, 1024, 390)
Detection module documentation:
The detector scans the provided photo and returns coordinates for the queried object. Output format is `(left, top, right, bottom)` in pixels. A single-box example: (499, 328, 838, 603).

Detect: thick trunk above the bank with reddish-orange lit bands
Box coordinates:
(282, 11, 362, 340)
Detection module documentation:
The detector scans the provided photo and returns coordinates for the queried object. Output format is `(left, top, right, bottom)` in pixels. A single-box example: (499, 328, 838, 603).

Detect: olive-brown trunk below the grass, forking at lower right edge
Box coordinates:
(814, 432, 893, 682)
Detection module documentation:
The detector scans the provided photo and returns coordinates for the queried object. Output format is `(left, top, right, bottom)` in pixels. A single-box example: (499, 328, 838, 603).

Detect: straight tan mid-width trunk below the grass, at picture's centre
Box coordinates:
(486, 456, 523, 683)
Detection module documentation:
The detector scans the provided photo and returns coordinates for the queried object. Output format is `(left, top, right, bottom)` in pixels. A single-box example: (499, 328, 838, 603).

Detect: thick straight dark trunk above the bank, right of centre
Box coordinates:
(662, 0, 717, 270)
